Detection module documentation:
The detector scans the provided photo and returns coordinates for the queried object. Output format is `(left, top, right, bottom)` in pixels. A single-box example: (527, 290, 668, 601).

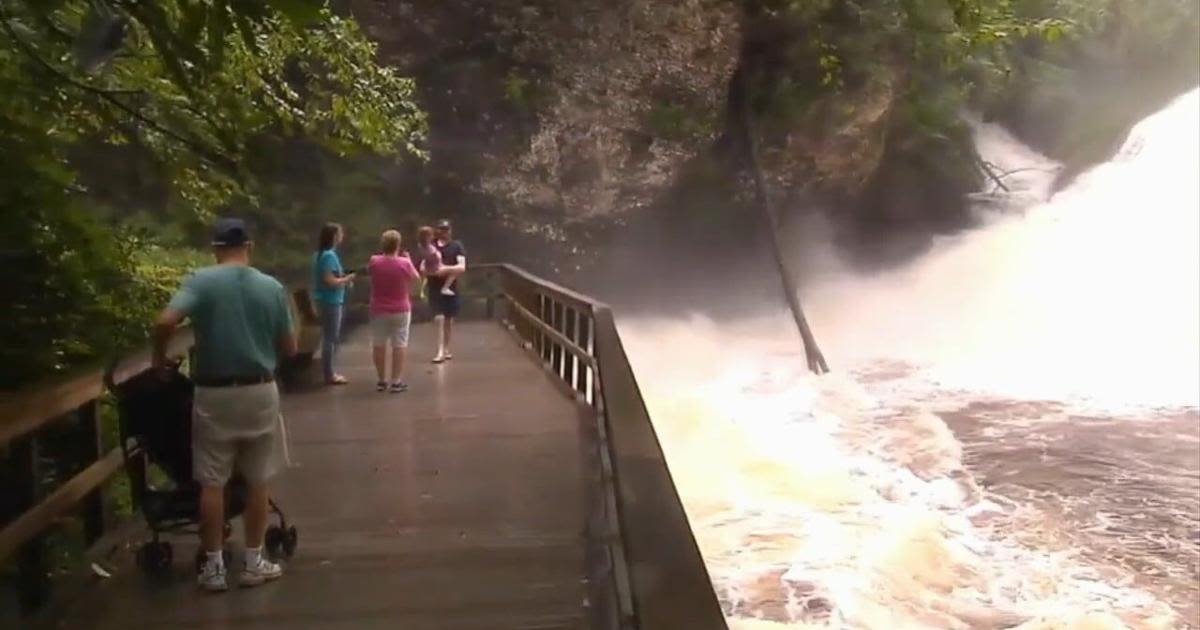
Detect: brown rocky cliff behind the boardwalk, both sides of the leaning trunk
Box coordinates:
(342, 0, 1195, 286)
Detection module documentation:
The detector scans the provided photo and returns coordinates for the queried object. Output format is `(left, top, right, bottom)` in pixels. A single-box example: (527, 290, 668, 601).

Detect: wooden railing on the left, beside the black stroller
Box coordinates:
(0, 292, 319, 612)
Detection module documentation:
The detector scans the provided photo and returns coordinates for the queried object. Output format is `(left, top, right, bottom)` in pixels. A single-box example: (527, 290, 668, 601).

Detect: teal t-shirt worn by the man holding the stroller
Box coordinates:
(170, 265, 292, 378)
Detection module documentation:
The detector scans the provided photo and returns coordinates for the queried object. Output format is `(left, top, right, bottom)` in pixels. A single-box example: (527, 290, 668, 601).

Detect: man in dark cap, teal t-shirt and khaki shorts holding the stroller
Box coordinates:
(154, 218, 296, 590)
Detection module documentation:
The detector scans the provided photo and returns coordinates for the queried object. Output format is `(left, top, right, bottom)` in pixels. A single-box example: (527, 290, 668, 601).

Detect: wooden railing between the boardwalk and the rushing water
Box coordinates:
(472, 264, 726, 630)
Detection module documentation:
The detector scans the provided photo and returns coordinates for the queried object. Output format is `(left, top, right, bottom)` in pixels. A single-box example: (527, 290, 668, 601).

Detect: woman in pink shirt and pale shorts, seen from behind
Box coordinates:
(367, 229, 420, 394)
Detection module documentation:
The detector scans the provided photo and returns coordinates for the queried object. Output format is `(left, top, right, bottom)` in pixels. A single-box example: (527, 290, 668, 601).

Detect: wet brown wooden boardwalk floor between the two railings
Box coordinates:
(49, 322, 588, 630)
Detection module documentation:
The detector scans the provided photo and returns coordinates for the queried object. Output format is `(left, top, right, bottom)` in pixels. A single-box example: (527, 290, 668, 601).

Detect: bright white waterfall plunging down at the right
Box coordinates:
(805, 91, 1200, 407)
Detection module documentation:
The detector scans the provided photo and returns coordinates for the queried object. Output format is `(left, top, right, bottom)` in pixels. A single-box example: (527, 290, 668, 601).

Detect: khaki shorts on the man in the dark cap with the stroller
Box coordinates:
(192, 383, 286, 486)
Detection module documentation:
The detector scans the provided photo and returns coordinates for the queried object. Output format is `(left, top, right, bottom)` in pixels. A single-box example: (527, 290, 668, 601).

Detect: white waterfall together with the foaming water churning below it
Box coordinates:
(622, 91, 1200, 630)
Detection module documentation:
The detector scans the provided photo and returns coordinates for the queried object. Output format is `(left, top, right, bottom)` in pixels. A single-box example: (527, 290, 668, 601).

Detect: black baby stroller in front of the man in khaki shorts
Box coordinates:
(104, 357, 298, 575)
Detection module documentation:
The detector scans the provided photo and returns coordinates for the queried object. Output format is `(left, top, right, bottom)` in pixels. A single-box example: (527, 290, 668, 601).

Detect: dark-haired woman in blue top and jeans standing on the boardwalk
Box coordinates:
(312, 223, 354, 385)
